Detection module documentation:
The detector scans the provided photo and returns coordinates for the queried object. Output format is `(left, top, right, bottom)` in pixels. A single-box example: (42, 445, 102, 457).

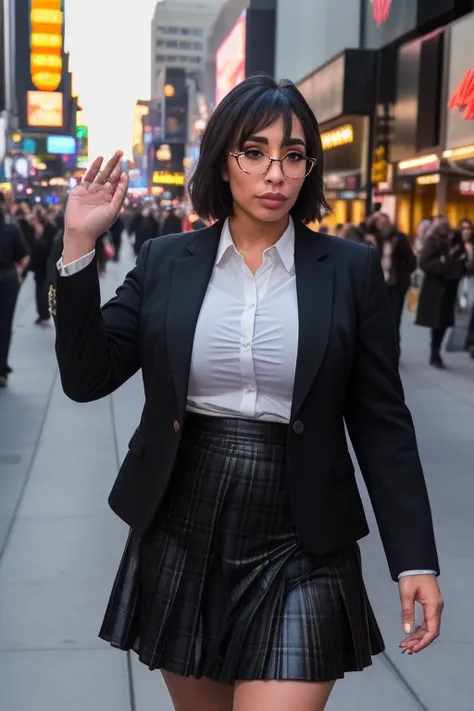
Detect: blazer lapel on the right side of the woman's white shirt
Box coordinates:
(291, 223, 334, 420)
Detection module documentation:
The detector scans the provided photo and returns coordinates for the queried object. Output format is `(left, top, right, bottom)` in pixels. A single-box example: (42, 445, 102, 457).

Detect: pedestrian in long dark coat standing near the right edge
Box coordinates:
(416, 217, 467, 368)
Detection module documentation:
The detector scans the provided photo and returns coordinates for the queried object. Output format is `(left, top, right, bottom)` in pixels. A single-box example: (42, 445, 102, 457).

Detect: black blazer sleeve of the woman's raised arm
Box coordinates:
(50, 244, 149, 402)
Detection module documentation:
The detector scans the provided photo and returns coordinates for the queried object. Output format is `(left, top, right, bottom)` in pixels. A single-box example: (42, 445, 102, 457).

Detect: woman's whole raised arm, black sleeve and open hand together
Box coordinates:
(53, 152, 138, 402)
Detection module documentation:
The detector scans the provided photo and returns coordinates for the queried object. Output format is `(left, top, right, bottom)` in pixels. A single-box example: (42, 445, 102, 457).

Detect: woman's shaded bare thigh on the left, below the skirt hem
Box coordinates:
(162, 671, 234, 711)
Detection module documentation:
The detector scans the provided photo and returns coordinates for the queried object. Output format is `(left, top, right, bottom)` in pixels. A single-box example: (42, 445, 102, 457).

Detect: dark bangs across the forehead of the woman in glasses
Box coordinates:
(231, 89, 294, 151)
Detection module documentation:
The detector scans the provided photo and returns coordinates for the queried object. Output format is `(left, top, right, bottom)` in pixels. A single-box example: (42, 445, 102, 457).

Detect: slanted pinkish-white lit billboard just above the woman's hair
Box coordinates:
(216, 11, 246, 104)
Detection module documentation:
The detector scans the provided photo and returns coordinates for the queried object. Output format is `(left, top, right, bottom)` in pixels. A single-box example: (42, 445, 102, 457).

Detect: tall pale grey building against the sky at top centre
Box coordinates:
(151, 0, 223, 99)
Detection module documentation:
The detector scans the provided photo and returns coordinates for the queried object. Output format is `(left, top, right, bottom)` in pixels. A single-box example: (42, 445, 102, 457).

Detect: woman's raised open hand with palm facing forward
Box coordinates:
(65, 151, 128, 242)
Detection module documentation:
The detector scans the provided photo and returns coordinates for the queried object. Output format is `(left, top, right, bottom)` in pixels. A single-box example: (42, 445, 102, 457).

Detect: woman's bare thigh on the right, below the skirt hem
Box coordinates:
(233, 681, 335, 711)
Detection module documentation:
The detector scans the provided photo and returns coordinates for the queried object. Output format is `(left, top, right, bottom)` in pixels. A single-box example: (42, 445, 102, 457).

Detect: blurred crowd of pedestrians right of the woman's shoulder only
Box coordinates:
(320, 212, 474, 368)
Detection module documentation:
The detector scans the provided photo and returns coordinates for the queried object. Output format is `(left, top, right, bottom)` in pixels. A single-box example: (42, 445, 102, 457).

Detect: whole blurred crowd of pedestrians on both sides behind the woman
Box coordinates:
(0, 193, 474, 387)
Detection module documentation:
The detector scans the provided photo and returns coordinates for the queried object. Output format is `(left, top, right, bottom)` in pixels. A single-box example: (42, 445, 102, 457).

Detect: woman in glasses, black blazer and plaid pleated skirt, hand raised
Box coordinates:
(53, 75, 442, 711)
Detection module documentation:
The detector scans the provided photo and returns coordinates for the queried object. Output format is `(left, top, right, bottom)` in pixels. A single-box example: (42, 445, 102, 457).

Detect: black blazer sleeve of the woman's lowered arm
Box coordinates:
(345, 249, 439, 580)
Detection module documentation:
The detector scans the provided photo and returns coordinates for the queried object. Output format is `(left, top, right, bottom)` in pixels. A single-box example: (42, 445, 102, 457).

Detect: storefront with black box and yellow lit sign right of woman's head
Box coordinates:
(299, 50, 374, 225)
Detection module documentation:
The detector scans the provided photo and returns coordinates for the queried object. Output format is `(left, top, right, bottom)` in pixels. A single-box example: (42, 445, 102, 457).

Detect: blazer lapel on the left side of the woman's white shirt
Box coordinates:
(166, 222, 222, 417)
